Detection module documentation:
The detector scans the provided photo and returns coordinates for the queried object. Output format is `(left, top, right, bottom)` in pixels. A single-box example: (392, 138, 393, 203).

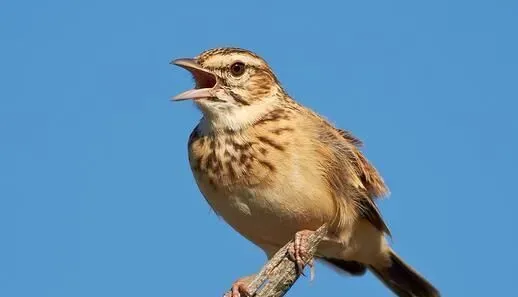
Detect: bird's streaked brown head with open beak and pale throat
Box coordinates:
(171, 48, 286, 130)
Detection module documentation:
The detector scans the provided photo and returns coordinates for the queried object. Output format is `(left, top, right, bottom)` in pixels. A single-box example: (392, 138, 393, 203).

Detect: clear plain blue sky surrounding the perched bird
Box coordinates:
(0, 0, 518, 297)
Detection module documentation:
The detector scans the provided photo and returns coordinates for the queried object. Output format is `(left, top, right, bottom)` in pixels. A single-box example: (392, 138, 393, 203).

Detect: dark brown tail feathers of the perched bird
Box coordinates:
(369, 250, 440, 297)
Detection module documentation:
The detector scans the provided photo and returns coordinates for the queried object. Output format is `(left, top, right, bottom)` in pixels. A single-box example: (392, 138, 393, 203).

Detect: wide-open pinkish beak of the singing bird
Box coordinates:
(171, 59, 218, 101)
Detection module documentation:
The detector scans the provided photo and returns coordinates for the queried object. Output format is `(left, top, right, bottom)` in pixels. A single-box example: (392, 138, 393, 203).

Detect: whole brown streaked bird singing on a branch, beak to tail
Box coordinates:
(171, 47, 440, 297)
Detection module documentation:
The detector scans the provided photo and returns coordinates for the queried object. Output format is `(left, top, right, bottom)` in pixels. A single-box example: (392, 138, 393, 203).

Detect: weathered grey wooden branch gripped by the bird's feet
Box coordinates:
(224, 224, 327, 297)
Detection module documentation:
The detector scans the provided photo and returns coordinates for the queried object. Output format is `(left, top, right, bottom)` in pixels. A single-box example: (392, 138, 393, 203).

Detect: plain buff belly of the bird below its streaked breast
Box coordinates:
(195, 176, 334, 255)
